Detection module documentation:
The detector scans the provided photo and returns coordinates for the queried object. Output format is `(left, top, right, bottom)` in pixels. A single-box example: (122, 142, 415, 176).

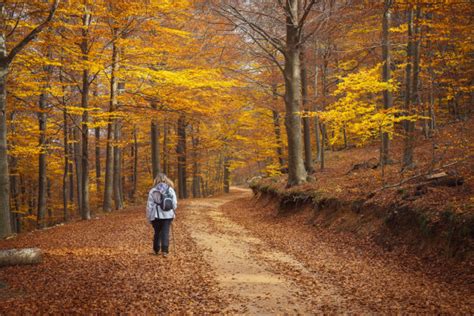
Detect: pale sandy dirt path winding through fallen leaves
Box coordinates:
(185, 188, 358, 315)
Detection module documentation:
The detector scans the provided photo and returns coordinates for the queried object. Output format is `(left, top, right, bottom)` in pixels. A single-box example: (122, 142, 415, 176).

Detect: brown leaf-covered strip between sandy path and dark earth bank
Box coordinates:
(222, 188, 474, 314)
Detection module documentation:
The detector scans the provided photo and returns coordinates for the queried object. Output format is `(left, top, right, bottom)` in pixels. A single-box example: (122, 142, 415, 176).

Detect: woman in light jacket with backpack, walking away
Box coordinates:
(146, 173, 178, 257)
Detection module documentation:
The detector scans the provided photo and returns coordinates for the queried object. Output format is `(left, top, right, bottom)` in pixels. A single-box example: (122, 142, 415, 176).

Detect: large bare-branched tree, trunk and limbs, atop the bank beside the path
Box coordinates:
(220, 0, 316, 186)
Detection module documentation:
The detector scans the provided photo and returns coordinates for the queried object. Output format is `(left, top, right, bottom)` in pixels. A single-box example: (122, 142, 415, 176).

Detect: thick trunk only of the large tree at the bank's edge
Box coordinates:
(284, 0, 307, 187)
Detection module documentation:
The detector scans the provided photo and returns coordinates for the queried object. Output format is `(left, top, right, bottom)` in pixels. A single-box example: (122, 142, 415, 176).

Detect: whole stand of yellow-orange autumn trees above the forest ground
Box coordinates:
(0, 0, 473, 237)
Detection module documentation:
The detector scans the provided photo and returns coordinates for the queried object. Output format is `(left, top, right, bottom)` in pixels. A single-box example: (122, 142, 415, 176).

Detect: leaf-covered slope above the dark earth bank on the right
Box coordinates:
(256, 118, 474, 216)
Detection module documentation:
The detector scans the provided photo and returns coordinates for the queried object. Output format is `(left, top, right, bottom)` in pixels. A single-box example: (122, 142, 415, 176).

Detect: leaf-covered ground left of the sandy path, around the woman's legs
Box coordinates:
(0, 201, 226, 315)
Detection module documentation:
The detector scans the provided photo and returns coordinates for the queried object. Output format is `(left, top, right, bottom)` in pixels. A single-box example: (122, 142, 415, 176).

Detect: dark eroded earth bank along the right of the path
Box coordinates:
(252, 183, 474, 274)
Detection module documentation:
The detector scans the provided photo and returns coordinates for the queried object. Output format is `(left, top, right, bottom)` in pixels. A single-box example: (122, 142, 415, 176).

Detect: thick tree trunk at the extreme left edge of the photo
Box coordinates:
(0, 25, 12, 238)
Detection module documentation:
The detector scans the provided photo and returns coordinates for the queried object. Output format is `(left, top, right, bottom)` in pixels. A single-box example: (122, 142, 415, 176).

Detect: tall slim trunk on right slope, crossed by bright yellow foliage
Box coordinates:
(380, 0, 393, 165)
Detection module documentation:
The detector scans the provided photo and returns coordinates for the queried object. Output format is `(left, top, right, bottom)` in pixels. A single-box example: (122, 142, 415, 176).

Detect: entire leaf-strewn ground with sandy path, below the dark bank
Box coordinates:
(0, 189, 474, 314)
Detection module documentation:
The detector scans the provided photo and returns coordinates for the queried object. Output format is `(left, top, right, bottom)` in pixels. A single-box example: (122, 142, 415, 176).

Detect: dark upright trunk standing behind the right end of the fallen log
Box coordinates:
(36, 92, 47, 228)
